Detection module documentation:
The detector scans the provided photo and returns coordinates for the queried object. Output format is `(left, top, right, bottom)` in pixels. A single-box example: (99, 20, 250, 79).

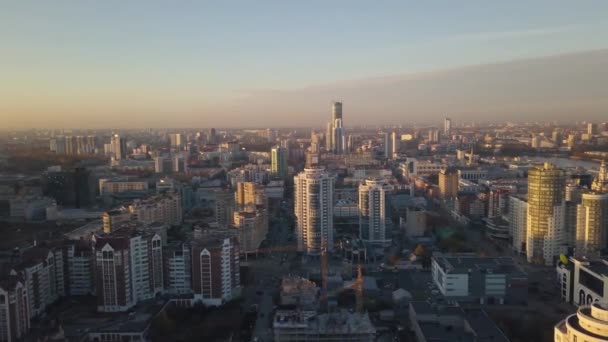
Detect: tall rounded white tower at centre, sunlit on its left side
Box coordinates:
(294, 168, 335, 255)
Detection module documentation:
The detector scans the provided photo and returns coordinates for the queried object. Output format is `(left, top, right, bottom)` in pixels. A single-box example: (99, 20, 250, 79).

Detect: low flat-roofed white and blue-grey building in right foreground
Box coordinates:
(431, 254, 528, 304)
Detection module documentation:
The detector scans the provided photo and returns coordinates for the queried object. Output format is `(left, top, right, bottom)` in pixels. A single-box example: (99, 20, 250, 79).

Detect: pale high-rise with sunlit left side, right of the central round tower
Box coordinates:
(359, 179, 392, 244)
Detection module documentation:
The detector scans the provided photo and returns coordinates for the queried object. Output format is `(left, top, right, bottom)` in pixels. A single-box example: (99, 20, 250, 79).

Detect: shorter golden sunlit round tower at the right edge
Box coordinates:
(575, 193, 608, 258)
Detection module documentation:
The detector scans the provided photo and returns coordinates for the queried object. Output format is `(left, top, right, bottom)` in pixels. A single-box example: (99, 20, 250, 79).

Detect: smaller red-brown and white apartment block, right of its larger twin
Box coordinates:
(190, 232, 241, 305)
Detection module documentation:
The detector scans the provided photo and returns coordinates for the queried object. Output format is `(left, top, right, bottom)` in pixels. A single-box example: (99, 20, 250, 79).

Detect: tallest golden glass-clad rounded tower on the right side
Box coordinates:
(526, 163, 566, 265)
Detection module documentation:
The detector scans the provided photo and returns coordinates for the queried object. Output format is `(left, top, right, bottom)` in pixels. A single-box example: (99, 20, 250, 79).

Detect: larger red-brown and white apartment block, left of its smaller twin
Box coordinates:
(95, 227, 163, 312)
